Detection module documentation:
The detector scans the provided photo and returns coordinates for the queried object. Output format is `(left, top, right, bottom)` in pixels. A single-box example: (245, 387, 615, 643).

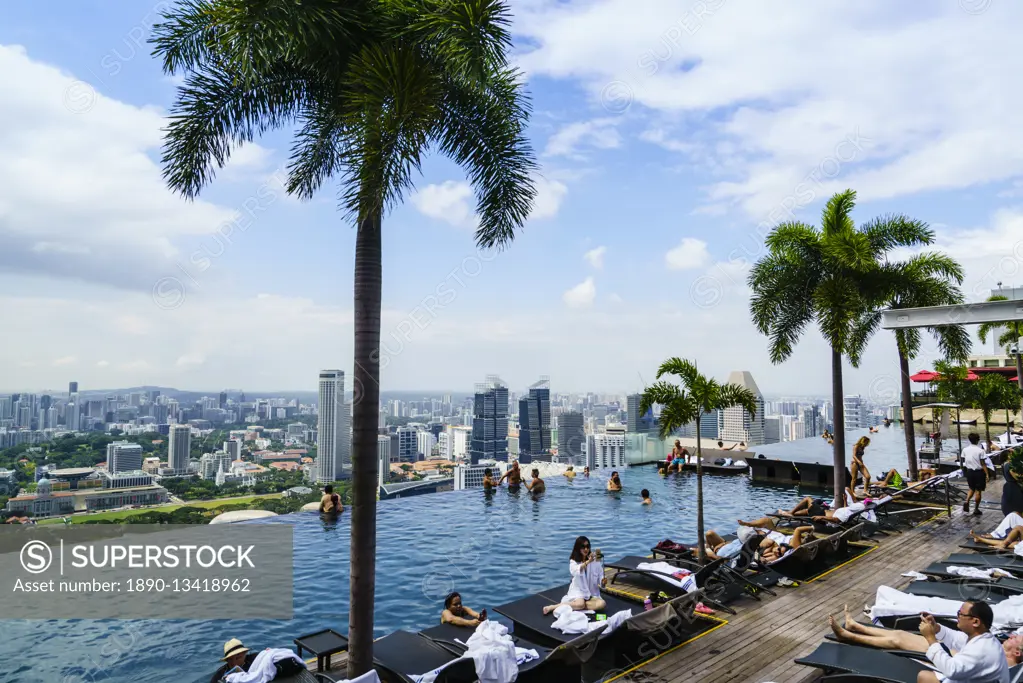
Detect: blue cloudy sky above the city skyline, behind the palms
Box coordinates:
(0, 0, 1023, 402)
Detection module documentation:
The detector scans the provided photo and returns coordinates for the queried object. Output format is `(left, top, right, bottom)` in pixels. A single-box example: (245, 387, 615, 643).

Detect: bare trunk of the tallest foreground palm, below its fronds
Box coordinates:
(348, 209, 382, 679)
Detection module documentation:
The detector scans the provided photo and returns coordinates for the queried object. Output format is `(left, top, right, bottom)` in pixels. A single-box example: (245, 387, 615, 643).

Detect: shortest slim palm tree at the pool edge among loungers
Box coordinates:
(639, 358, 757, 564)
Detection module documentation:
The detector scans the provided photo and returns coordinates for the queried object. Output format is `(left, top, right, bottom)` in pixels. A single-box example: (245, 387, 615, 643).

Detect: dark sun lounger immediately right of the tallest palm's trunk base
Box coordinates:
(373, 630, 477, 683)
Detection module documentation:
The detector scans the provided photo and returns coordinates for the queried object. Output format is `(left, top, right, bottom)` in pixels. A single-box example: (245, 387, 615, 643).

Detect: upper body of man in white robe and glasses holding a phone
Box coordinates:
(917, 602, 1009, 683)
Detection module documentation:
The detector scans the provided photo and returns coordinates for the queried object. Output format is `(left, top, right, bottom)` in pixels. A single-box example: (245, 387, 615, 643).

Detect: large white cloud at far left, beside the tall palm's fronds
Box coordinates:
(0, 46, 241, 289)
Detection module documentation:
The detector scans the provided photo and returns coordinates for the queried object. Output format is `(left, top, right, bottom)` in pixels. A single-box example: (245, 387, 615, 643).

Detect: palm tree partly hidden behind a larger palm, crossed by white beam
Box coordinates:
(850, 254, 971, 481)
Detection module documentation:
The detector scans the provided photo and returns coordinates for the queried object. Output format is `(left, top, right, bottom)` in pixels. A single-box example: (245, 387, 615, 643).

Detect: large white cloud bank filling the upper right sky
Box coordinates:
(516, 0, 1023, 220)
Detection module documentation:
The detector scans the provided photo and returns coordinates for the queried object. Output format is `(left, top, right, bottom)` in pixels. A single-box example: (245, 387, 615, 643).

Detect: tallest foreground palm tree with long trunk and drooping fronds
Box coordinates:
(152, 0, 536, 678)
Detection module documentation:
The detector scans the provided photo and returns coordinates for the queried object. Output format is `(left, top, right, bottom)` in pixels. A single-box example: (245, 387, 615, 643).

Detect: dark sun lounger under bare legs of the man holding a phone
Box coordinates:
(795, 642, 931, 683)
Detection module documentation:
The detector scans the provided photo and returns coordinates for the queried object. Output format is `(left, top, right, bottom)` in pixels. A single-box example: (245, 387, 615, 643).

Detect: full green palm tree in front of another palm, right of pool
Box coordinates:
(749, 190, 934, 501)
